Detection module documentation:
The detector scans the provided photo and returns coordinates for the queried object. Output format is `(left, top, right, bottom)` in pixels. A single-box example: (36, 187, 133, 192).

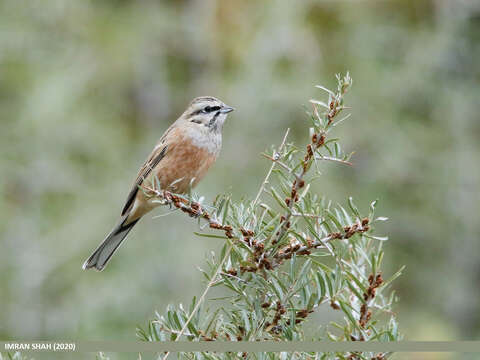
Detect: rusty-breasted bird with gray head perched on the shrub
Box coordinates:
(82, 96, 234, 271)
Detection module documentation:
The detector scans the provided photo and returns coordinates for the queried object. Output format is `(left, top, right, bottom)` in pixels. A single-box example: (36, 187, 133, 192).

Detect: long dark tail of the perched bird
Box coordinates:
(82, 216, 140, 271)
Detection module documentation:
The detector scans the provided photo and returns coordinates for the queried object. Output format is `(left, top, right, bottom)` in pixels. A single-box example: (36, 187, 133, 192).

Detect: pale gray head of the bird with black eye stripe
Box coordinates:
(182, 96, 234, 131)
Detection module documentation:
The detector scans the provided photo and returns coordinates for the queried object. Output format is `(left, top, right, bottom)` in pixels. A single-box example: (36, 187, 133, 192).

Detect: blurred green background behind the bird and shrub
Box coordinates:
(0, 0, 480, 358)
